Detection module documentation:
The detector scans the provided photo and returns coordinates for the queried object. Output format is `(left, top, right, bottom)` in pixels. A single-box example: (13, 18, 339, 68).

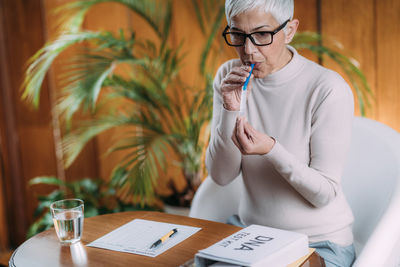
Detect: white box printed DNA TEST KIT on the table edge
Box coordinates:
(195, 225, 309, 267)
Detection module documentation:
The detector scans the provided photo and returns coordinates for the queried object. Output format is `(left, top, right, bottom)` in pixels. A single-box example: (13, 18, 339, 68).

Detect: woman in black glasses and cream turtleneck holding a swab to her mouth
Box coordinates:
(206, 0, 355, 267)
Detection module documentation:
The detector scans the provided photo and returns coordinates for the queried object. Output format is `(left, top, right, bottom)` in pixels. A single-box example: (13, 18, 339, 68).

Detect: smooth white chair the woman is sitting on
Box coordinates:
(189, 117, 400, 267)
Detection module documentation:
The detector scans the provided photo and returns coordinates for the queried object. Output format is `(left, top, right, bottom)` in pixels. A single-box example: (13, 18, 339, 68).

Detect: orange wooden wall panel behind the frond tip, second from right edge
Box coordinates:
(321, 0, 379, 118)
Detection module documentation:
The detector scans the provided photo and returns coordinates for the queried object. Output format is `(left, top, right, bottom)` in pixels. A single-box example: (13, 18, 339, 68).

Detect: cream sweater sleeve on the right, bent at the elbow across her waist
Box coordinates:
(264, 74, 354, 207)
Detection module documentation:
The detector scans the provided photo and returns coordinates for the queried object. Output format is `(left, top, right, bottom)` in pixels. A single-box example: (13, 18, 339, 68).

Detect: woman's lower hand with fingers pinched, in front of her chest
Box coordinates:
(232, 117, 275, 155)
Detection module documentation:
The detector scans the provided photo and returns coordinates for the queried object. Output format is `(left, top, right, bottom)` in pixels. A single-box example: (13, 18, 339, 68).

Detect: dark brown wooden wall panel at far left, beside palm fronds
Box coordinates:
(7, 0, 56, 245)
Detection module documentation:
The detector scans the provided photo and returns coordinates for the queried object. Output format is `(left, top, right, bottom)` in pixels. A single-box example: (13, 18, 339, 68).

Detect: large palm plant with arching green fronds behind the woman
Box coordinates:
(23, 0, 369, 215)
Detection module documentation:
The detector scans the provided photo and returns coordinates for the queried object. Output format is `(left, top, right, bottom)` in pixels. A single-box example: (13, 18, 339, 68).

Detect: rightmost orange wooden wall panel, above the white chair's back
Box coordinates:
(375, 0, 400, 131)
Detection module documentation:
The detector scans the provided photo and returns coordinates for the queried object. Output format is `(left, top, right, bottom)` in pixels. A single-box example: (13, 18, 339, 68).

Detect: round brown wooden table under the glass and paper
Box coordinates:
(9, 211, 324, 267)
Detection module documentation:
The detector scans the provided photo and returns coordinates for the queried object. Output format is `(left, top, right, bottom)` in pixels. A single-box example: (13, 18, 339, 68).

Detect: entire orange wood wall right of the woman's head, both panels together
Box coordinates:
(321, 0, 400, 127)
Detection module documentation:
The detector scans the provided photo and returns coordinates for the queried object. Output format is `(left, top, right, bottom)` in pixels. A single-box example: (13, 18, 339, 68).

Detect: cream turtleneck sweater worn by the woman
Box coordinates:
(206, 46, 354, 245)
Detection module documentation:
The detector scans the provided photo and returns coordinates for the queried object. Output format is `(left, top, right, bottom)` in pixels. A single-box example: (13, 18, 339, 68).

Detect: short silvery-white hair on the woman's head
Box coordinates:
(225, 0, 294, 25)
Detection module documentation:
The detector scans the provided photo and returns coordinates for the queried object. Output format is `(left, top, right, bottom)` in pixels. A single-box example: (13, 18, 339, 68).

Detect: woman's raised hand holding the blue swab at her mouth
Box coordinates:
(221, 65, 252, 111)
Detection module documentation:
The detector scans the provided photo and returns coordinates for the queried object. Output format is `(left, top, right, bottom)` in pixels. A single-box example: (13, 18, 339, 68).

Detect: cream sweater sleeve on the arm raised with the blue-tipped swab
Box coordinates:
(206, 61, 242, 185)
